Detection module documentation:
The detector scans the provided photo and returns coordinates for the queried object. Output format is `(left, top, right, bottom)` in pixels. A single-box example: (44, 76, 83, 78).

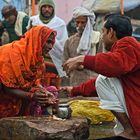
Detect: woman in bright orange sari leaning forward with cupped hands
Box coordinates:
(0, 26, 57, 118)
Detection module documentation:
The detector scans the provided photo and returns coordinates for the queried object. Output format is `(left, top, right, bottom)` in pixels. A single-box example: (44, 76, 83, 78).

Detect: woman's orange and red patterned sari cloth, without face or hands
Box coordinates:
(0, 26, 56, 118)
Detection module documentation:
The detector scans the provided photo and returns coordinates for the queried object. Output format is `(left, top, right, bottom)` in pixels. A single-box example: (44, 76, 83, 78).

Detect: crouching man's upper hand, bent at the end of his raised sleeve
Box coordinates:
(63, 55, 85, 75)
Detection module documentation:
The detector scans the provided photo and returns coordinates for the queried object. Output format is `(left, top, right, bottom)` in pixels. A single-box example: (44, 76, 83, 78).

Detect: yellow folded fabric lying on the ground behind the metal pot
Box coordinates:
(69, 100, 115, 124)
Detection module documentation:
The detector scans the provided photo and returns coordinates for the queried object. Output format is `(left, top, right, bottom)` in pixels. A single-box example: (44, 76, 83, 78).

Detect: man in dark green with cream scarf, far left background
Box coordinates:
(0, 5, 29, 45)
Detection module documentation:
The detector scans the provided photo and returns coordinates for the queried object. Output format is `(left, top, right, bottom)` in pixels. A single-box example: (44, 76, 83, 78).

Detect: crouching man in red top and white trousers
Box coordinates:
(64, 15, 140, 139)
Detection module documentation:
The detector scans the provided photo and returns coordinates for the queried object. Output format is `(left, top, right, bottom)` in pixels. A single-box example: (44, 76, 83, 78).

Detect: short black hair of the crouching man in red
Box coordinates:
(104, 14, 132, 39)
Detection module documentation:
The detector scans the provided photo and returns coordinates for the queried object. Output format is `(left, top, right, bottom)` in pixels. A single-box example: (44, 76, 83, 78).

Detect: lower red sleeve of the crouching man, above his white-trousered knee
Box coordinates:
(71, 78, 97, 97)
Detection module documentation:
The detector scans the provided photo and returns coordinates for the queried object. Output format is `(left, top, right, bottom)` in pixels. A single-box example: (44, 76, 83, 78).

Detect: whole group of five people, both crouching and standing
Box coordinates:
(0, 0, 140, 139)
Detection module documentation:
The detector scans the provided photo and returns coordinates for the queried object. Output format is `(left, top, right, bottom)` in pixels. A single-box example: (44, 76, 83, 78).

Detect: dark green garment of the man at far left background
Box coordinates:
(0, 16, 29, 42)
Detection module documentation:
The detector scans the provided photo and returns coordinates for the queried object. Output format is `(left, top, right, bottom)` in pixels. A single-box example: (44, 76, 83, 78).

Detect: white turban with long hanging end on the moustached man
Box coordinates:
(73, 7, 95, 55)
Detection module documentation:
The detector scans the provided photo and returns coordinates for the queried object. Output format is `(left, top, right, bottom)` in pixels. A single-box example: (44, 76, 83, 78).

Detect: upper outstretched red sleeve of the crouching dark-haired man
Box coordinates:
(83, 44, 138, 77)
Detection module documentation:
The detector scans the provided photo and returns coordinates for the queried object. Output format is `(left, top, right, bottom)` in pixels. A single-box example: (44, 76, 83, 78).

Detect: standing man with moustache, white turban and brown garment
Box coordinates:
(63, 7, 100, 86)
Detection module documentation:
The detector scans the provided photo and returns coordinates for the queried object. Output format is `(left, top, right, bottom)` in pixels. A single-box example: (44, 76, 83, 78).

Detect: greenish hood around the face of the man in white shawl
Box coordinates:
(39, 0, 55, 24)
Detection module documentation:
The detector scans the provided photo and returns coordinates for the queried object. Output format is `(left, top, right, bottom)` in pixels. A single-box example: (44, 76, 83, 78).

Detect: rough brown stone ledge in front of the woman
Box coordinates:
(0, 116, 90, 140)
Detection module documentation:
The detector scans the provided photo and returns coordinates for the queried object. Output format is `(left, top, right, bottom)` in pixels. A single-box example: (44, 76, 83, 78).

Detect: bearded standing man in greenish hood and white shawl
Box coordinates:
(29, 0, 68, 77)
